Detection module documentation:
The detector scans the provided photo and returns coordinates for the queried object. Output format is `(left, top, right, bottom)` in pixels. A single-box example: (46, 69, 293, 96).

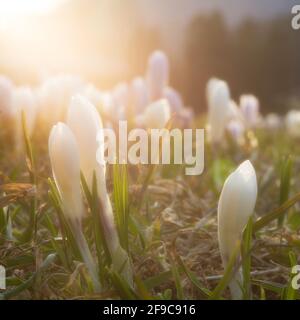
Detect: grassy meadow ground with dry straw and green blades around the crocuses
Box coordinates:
(0, 121, 300, 299)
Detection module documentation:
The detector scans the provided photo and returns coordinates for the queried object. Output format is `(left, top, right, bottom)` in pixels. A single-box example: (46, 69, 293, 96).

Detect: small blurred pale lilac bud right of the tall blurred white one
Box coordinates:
(240, 94, 260, 128)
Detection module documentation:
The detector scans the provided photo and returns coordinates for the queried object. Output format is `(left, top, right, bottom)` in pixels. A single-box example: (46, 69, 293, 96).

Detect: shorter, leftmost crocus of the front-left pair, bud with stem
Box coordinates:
(49, 123, 100, 291)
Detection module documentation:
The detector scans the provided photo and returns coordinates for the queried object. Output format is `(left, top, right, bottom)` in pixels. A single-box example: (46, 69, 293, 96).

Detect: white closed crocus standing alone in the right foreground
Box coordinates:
(218, 160, 257, 299)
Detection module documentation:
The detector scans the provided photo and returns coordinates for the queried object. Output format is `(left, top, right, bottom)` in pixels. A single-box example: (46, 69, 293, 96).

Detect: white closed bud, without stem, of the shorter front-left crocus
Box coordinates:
(49, 122, 84, 221)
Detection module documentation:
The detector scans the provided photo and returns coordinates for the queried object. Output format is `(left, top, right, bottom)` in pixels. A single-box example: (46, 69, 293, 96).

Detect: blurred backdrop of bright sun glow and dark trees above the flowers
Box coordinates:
(0, 0, 300, 113)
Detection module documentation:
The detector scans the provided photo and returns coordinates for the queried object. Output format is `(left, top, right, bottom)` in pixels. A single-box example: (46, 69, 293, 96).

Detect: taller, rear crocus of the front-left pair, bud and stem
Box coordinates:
(67, 95, 132, 284)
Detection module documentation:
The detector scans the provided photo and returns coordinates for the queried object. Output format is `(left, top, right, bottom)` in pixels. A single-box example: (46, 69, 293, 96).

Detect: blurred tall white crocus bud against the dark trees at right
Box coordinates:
(208, 80, 230, 143)
